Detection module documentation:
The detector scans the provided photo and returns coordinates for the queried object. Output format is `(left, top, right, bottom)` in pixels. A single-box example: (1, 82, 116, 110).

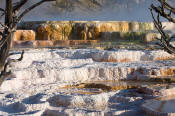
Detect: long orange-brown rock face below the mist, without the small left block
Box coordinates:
(18, 21, 155, 42)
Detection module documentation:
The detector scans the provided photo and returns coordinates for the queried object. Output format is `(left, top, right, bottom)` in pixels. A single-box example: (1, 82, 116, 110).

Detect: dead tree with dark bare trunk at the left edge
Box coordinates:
(0, 0, 55, 85)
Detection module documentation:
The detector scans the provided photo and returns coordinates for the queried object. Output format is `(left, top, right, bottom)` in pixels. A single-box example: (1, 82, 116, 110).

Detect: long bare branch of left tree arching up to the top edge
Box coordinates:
(18, 0, 55, 22)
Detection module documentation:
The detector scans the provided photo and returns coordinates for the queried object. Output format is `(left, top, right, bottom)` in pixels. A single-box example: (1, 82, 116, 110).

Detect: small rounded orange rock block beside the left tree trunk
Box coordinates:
(13, 30, 35, 41)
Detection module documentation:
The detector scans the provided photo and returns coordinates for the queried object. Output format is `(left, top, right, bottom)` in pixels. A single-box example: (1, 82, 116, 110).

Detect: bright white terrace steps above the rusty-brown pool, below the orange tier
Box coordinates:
(1, 49, 175, 91)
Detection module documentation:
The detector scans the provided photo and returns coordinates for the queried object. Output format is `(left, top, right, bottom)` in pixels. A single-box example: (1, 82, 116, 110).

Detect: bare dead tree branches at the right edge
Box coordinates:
(150, 0, 175, 54)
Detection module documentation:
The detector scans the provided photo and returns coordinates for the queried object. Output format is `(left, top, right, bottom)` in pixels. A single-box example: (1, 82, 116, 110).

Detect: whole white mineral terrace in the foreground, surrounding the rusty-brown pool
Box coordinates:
(0, 49, 175, 116)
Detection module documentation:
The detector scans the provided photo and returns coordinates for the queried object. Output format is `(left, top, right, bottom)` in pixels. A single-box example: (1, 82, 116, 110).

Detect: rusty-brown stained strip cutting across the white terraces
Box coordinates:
(62, 78, 175, 95)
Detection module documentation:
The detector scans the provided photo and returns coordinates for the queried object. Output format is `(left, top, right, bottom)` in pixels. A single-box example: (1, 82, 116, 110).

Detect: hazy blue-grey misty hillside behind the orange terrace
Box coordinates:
(0, 0, 157, 21)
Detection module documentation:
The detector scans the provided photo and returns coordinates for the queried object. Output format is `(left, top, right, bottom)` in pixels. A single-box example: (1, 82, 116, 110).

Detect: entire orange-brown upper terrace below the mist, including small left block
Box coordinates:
(7, 21, 171, 47)
